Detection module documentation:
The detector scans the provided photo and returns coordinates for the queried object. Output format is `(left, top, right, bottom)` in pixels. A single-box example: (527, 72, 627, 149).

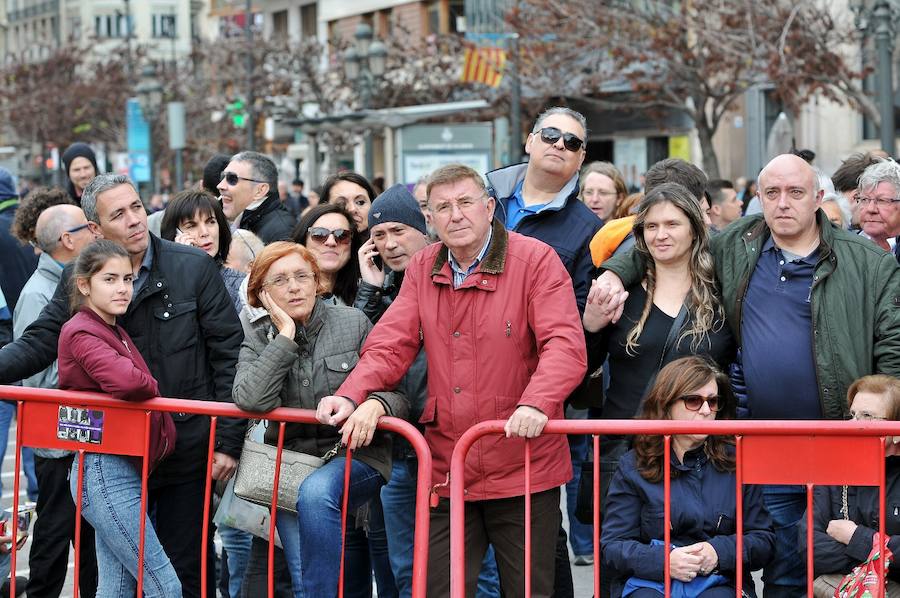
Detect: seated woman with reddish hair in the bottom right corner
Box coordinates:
(800, 375, 900, 598)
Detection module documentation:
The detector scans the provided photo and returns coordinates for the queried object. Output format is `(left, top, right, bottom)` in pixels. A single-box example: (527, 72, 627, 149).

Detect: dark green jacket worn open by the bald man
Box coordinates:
(601, 210, 900, 419)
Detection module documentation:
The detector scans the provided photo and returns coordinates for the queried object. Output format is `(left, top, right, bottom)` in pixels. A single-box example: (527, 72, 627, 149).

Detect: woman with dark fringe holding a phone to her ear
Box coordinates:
(160, 189, 246, 313)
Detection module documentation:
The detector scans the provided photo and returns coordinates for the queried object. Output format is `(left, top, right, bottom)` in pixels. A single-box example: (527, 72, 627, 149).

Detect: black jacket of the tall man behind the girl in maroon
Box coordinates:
(0, 235, 245, 486)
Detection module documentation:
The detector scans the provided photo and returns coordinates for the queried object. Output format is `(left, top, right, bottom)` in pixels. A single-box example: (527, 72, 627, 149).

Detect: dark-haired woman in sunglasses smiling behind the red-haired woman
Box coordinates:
(291, 203, 362, 305)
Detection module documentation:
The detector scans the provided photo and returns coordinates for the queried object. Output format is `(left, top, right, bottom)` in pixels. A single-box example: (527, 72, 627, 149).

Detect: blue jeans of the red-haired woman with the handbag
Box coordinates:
(275, 457, 384, 598)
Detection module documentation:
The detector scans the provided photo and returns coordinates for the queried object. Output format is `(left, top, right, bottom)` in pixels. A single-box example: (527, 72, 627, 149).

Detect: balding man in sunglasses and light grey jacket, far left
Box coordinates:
(11, 203, 97, 596)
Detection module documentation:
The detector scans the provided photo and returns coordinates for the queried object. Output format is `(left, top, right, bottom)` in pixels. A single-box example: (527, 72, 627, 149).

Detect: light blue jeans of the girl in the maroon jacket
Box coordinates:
(69, 453, 181, 598)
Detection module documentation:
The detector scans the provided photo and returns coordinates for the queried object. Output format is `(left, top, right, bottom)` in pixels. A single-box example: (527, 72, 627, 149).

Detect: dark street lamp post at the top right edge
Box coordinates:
(850, 0, 896, 156)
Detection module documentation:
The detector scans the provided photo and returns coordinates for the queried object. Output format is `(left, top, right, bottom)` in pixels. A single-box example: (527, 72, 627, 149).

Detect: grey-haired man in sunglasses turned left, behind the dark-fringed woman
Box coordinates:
(216, 152, 294, 245)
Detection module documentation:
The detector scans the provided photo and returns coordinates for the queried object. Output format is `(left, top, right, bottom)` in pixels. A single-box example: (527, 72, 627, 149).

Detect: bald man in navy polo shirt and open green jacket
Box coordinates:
(588, 154, 900, 598)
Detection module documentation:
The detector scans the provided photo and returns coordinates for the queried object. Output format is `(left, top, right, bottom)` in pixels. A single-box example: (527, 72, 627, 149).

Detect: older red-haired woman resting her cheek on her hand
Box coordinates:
(234, 241, 409, 597)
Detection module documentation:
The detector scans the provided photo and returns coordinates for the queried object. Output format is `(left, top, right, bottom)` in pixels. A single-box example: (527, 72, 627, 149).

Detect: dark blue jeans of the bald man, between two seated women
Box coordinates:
(763, 485, 806, 596)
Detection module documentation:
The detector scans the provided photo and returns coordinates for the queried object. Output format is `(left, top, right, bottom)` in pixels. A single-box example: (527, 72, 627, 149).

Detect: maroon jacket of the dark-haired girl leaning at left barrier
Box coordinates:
(59, 308, 176, 469)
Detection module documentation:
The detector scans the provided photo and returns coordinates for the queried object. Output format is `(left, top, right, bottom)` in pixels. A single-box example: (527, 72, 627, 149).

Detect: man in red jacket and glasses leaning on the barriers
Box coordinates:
(319, 165, 587, 598)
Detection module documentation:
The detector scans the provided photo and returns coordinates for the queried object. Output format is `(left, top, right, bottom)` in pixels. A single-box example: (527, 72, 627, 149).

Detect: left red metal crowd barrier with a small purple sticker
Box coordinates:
(0, 386, 431, 598)
